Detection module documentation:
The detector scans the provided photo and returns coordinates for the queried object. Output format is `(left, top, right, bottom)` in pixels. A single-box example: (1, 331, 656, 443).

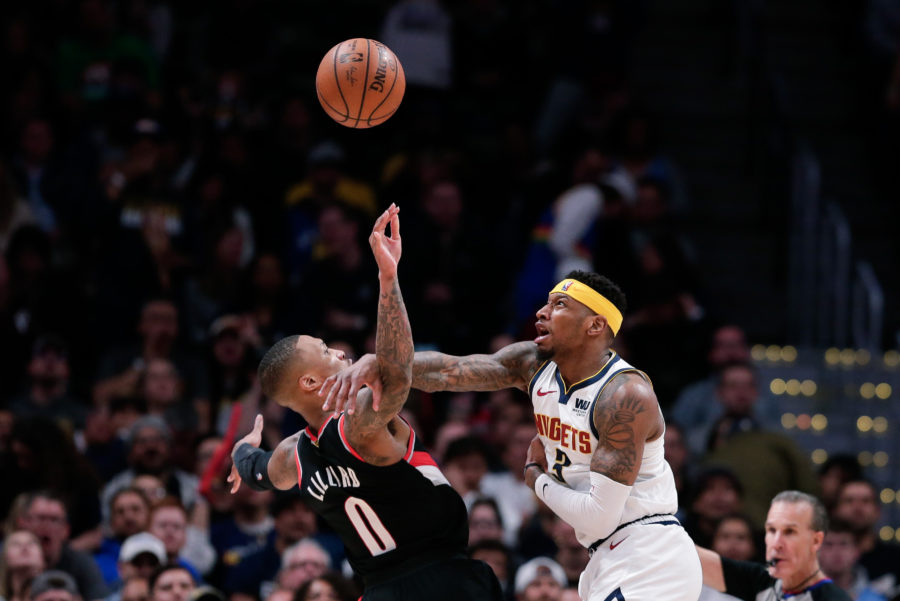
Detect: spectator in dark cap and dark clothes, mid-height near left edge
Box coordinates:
(9, 334, 88, 432)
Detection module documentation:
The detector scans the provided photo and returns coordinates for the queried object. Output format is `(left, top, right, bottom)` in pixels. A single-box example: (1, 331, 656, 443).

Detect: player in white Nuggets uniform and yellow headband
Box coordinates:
(322, 271, 702, 601)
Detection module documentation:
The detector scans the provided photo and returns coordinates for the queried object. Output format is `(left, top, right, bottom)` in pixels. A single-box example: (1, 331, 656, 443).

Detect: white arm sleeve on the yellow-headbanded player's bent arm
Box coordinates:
(534, 471, 631, 547)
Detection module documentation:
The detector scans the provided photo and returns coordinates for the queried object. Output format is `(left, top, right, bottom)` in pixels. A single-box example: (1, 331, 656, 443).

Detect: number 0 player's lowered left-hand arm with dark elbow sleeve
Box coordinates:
(228, 415, 300, 493)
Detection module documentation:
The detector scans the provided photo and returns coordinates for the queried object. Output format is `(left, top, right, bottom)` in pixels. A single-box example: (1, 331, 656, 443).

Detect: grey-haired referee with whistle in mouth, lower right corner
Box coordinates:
(697, 490, 850, 601)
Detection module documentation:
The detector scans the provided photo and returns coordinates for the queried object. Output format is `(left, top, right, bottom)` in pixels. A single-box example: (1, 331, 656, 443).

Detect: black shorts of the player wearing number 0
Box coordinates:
(362, 557, 503, 601)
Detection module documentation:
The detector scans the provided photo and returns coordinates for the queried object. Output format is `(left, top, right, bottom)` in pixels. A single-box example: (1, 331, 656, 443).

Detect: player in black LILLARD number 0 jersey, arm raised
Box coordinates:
(228, 205, 502, 601)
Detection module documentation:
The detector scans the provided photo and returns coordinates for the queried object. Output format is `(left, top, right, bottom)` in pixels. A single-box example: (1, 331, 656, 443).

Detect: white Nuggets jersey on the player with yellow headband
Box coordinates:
(528, 351, 678, 546)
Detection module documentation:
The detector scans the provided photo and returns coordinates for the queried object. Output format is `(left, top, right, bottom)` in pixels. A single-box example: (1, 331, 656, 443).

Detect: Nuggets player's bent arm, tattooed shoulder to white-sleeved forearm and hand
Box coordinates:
(525, 373, 659, 540)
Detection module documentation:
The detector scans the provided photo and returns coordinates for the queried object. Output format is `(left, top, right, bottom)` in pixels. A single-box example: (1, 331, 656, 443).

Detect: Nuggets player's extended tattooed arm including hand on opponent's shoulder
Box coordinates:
(319, 341, 540, 413)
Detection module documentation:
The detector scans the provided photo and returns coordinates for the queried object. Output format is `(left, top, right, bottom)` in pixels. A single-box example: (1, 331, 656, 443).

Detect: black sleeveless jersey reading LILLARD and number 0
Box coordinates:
(297, 415, 469, 582)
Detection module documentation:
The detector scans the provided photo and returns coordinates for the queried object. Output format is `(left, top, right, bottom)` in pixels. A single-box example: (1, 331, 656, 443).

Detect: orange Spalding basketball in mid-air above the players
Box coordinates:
(316, 38, 406, 129)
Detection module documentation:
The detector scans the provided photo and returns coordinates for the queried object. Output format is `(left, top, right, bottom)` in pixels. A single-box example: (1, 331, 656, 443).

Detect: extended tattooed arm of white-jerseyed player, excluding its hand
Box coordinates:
(412, 342, 540, 392)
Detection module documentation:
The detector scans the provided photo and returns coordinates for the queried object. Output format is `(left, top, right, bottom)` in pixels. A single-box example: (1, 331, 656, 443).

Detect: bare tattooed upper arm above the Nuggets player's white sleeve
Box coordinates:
(591, 372, 659, 486)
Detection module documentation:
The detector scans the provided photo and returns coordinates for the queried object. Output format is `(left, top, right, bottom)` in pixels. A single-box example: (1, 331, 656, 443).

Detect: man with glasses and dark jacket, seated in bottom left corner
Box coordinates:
(24, 492, 108, 601)
